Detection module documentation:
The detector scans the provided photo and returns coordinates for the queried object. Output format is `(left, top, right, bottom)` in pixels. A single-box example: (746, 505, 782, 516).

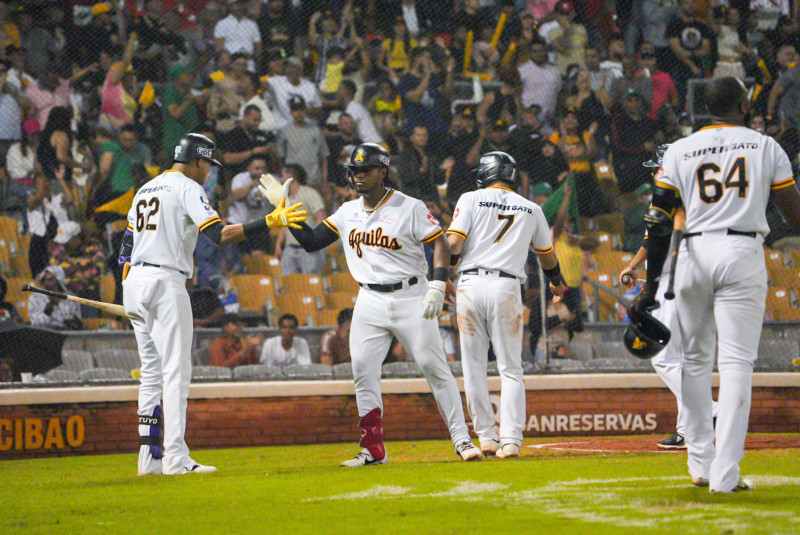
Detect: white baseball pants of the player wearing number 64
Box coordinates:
(676, 231, 767, 492)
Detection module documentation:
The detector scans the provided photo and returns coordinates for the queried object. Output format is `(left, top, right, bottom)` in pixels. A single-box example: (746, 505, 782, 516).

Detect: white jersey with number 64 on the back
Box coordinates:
(655, 125, 795, 235)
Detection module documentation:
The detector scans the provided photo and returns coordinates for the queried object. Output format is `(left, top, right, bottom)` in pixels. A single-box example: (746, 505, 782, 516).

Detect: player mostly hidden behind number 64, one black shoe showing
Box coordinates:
(619, 145, 717, 450)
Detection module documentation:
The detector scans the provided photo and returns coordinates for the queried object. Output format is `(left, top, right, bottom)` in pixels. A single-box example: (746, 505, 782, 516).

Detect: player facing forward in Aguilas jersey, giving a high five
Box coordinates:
(269, 143, 481, 466)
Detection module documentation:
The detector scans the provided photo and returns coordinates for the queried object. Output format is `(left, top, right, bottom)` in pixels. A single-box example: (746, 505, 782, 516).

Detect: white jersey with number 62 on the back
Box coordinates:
(128, 170, 220, 277)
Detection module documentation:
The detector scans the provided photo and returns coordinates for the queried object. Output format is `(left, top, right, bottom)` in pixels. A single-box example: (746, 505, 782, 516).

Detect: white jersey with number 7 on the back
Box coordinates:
(447, 186, 553, 281)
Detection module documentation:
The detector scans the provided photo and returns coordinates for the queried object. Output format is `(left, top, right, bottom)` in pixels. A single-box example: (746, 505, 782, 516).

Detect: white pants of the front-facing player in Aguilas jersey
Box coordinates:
(350, 279, 470, 444)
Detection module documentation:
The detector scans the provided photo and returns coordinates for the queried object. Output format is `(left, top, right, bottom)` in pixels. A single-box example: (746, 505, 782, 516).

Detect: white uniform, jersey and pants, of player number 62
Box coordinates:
(122, 170, 220, 474)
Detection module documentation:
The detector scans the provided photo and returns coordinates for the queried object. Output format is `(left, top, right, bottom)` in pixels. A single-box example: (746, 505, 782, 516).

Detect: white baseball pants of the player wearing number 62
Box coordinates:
(122, 266, 195, 474)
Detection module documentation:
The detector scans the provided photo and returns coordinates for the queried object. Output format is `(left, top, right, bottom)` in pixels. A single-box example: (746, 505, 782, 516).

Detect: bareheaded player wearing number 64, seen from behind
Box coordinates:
(628, 76, 800, 492)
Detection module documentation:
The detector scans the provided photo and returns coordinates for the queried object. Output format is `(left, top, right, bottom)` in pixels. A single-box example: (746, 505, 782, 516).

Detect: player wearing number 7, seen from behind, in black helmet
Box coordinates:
(447, 151, 567, 458)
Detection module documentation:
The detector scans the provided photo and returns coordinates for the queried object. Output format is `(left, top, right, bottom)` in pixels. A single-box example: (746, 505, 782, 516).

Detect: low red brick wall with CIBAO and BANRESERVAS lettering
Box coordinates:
(0, 387, 800, 459)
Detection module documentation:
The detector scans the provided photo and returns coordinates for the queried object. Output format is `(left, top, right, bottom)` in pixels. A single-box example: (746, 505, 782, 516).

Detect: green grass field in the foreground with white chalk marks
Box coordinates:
(0, 439, 800, 535)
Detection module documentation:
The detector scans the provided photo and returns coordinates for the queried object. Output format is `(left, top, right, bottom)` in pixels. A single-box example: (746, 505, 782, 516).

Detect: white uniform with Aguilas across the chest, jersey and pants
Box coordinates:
(323, 191, 476, 444)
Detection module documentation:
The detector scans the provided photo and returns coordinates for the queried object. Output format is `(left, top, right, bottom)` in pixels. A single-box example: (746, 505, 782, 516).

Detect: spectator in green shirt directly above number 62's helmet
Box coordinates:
(161, 61, 205, 164)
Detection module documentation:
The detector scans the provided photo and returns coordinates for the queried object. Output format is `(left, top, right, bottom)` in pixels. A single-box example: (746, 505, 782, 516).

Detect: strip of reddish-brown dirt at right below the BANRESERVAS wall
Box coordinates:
(526, 434, 800, 453)
